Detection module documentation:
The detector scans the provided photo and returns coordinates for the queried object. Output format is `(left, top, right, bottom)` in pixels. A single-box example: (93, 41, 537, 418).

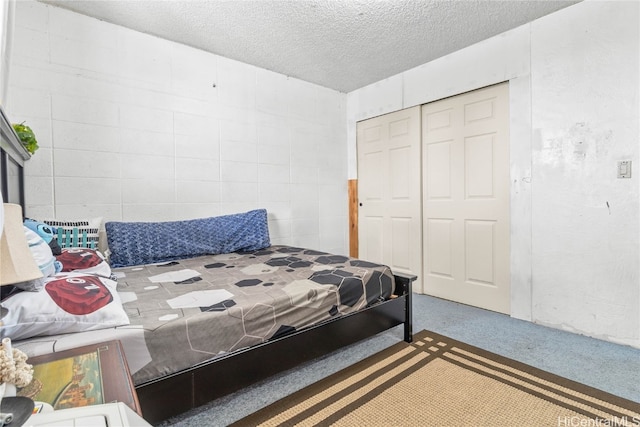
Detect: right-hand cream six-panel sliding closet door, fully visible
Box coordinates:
(422, 83, 510, 314)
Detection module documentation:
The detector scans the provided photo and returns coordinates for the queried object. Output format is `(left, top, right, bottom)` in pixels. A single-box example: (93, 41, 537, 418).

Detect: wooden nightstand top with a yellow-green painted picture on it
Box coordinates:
(18, 341, 142, 416)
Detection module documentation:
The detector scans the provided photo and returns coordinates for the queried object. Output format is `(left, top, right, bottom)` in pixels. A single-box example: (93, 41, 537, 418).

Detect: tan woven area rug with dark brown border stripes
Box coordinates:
(233, 331, 640, 427)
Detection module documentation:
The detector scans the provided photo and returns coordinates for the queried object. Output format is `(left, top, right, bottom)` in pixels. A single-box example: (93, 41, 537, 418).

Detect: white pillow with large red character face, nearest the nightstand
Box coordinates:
(2, 273, 129, 340)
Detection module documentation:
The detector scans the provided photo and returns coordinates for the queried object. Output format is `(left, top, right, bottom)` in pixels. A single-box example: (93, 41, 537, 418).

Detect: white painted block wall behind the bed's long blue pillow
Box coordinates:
(6, 1, 348, 254)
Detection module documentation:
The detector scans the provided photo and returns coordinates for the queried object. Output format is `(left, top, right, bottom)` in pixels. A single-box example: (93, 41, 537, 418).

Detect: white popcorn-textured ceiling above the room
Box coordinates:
(40, 0, 577, 92)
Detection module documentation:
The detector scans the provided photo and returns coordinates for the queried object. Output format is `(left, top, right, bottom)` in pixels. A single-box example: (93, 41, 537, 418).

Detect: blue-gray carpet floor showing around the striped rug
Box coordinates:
(160, 295, 640, 427)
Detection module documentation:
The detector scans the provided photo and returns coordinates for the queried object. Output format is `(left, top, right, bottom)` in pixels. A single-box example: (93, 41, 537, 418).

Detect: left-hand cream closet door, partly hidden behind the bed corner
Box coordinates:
(357, 106, 422, 292)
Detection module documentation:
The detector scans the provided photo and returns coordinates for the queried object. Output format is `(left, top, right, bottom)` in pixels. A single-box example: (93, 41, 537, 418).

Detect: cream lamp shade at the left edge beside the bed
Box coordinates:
(0, 203, 42, 286)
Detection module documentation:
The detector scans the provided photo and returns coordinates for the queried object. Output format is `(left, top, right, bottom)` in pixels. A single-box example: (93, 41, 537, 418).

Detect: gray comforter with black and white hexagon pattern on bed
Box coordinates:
(113, 246, 395, 384)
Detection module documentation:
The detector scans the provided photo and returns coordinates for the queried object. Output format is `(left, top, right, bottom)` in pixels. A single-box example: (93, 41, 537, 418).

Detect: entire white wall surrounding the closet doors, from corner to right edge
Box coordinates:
(347, 1, 640, 347)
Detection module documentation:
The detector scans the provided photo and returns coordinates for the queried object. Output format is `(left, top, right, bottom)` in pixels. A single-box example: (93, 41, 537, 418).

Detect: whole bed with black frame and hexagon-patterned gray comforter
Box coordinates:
(0, 107, 415, 423)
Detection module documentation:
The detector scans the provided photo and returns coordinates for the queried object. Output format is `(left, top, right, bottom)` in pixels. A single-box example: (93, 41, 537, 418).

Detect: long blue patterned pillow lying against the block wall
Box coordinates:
(105, 209, 271, 267)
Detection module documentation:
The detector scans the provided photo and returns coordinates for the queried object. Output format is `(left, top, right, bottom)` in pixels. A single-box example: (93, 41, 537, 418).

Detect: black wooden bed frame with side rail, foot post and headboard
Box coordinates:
(0, 108, 416, 424)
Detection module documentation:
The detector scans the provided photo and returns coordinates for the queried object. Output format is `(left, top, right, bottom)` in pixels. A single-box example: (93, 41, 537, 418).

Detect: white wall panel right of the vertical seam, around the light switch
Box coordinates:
(531, 2, 640, 347)
